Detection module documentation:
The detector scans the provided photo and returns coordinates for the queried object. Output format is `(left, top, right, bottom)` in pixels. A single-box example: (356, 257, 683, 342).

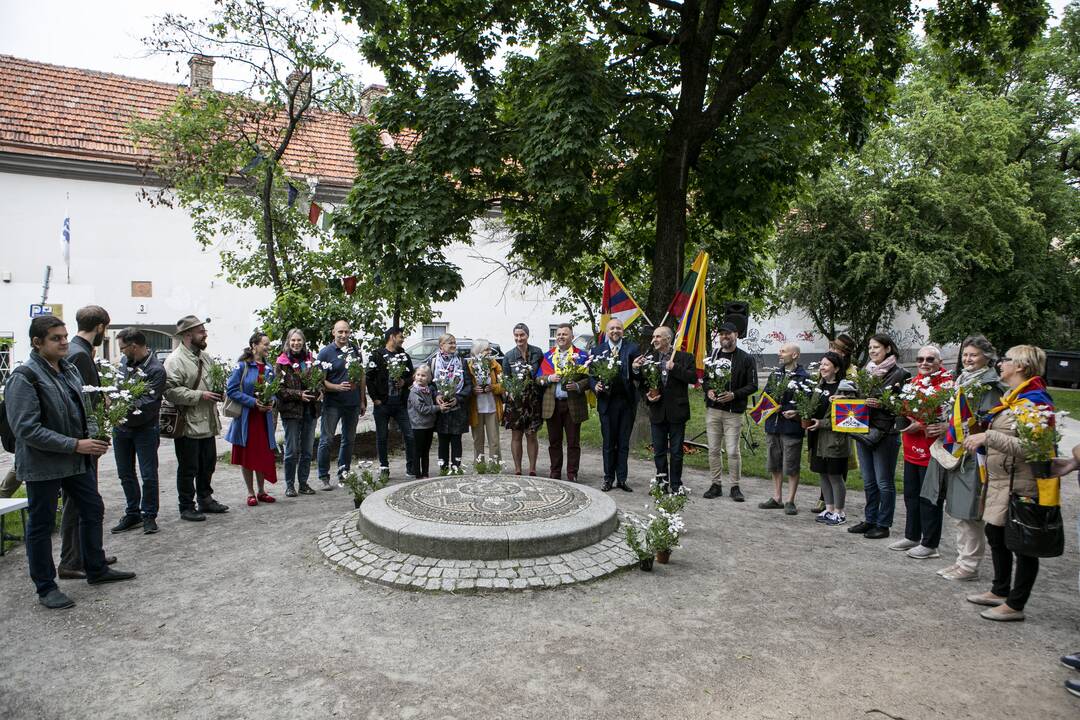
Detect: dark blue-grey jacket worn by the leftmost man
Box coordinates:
(4, 350, 92, 483)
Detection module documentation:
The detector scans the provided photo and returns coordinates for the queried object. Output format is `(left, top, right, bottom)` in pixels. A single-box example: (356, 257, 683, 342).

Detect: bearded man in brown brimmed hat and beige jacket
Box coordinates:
(165, 315, 229, 521)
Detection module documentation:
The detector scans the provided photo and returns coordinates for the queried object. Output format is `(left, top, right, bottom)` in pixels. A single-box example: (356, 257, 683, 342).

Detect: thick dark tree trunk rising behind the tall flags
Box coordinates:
(646, 122, 692, 323)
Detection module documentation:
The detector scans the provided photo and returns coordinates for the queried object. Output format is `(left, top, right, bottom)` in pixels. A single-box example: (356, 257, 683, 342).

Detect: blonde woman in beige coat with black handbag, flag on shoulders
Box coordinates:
(963, 345, 1053, 621)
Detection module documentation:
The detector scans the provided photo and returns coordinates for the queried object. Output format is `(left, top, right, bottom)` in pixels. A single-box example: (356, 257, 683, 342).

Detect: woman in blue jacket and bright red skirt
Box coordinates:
(225, 332, 278, 507)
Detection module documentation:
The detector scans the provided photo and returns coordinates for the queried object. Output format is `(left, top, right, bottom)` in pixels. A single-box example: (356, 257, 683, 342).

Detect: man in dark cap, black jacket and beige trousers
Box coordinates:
(702, 321, 757, 503)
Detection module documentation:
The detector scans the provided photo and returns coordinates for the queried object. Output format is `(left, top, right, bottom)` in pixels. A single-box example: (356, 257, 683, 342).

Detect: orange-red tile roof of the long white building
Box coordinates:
(0, 55, 384, 187)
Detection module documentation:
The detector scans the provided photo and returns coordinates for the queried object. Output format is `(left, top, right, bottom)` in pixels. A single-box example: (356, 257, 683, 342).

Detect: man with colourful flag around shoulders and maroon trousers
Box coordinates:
(537, 323, 589, 483)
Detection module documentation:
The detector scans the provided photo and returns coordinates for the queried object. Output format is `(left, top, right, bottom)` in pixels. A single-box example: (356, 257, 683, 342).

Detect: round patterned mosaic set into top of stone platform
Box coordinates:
(387, 475, 592, 525)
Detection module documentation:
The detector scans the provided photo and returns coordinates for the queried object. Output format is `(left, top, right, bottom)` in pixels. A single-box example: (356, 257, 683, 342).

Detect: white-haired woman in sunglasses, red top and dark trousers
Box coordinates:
(889, 345, 953, 560)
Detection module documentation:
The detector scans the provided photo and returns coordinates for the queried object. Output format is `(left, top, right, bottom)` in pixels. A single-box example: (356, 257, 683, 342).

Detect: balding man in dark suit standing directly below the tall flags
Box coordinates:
(634, 326, 698, 492)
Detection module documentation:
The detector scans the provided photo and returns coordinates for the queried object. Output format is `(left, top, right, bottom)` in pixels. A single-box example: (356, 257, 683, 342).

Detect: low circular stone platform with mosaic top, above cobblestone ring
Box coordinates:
(357, 475, 619, 560)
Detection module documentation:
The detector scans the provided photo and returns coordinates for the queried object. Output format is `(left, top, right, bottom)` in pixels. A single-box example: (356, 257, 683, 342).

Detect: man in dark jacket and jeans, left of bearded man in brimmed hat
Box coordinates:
(112, 327, 165, 535)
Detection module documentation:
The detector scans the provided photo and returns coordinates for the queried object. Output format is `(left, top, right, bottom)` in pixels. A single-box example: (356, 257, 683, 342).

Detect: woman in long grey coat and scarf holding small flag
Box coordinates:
(922, 335, 1003, 581)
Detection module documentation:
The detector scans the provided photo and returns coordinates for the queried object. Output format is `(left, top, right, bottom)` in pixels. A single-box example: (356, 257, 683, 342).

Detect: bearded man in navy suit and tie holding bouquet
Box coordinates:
(589, 317, 640, 492)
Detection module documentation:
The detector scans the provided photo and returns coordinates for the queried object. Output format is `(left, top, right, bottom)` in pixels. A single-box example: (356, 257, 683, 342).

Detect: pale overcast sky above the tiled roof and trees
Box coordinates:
(0, 0, 1066, 89)
